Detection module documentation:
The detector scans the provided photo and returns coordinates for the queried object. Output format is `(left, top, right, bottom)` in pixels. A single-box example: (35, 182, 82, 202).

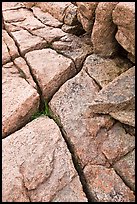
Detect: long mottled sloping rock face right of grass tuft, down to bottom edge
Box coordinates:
(49, 67, 135, 202)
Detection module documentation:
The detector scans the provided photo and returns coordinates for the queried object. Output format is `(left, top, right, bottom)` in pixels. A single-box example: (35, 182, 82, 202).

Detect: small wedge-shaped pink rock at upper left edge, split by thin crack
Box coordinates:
(2, 30, 19, 64)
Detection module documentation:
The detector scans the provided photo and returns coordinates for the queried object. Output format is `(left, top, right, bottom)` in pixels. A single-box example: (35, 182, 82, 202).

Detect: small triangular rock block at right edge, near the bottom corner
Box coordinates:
(113, 150, 135, 191)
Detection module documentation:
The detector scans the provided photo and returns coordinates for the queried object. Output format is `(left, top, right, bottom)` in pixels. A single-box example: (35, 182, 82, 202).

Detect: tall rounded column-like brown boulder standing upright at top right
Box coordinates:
(91, 2, 119, 57)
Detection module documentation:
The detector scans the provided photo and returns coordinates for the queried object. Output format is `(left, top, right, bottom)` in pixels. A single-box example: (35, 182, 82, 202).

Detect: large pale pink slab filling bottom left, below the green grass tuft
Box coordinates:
(2, 117, 87, 202)
